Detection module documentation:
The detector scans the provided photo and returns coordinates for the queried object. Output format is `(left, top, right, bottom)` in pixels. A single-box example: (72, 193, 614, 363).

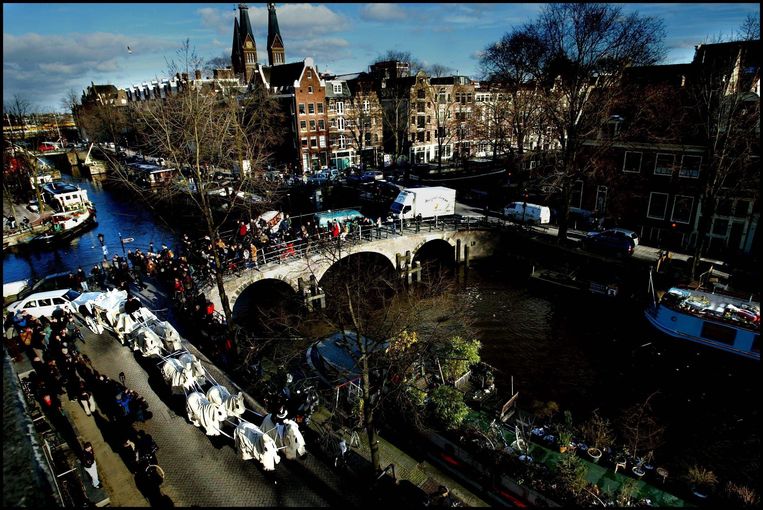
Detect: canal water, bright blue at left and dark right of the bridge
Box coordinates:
(3, 174, 760, 489)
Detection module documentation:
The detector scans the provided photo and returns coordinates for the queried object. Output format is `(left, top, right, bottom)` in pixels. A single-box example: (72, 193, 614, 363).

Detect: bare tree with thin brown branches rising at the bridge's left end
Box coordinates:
(108, 40, 284, 329)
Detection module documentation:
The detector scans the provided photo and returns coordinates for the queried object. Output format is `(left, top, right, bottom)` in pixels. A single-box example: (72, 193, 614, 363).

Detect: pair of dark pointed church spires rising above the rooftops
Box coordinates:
(231, 3, 286, 83)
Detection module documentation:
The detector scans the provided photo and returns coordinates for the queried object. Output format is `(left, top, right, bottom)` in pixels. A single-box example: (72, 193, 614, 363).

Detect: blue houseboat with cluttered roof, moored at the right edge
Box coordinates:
(645, 276, 760, 361)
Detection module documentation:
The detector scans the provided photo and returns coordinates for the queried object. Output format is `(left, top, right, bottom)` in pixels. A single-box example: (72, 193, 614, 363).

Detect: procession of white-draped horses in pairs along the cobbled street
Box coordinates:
(78, 289, 307, 471)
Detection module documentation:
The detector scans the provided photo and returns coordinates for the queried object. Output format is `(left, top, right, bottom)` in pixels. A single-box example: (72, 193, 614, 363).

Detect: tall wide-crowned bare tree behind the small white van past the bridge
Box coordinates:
(491, 3, 664, 240)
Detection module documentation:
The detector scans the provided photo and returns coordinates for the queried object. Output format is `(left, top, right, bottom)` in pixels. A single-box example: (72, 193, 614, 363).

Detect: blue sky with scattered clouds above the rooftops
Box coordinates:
(3, 2, 760, 112)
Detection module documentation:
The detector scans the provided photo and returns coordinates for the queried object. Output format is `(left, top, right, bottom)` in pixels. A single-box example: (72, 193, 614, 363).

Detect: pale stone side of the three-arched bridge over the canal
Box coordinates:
(202, 225, 499, 310)
